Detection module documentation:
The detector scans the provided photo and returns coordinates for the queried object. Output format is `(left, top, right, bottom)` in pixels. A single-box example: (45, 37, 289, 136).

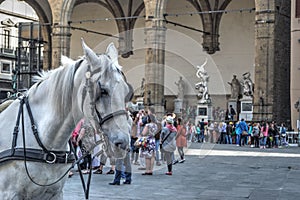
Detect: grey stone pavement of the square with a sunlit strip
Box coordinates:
(64, 143, 300, 200)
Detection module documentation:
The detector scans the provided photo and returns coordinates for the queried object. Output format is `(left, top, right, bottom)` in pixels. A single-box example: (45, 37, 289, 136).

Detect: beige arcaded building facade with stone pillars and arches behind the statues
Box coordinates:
(0, 0, 294, 128)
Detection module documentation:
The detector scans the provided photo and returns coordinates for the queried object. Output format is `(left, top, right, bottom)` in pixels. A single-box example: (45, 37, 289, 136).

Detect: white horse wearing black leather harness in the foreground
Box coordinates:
(0, 41, 132, 200)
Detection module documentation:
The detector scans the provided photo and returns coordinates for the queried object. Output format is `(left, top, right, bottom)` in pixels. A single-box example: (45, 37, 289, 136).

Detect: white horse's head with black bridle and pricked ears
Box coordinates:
(77, 40, 133, 158)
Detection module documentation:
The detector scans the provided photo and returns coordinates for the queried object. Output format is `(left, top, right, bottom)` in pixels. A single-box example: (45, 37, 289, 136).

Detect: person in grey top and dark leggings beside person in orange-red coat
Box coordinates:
(160, 116, 177, 175)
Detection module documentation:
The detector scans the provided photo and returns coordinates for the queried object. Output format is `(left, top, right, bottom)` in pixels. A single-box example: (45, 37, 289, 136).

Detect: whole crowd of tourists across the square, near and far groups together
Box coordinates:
(69, 108, 288, 185)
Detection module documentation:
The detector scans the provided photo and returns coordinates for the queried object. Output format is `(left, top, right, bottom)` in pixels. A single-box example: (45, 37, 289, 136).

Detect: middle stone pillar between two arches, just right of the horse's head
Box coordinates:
(144, 0, 166, 117)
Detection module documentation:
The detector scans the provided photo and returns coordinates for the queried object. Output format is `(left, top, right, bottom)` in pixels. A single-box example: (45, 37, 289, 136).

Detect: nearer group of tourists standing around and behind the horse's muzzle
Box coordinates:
(69, 108, 187, 185)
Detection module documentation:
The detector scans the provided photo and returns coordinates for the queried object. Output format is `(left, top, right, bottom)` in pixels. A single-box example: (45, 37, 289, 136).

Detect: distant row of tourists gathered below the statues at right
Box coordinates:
(187, 119, 288, 148)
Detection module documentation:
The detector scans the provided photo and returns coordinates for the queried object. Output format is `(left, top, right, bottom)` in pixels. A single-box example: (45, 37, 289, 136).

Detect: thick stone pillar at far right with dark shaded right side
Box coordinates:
(253, 0, 290, 122)
